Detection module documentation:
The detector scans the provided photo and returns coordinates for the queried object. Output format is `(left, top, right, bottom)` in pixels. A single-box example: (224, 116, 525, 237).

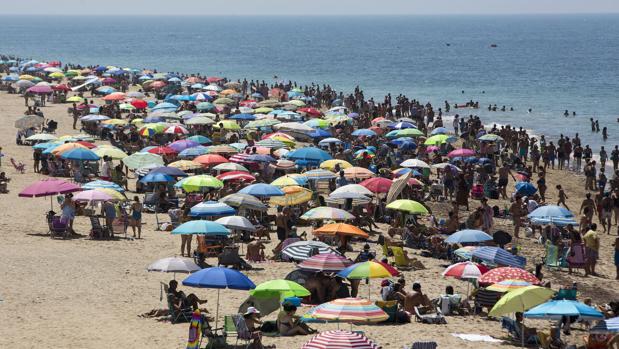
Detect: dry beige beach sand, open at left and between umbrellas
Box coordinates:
(0, 88, 619, 348)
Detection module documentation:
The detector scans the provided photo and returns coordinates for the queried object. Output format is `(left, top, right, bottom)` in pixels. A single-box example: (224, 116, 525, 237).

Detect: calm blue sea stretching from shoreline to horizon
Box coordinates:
(0, 13, 619, 150)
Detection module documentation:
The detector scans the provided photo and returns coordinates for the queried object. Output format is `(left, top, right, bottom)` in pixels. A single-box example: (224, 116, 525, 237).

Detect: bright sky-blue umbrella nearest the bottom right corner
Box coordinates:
(524, 299, 604, 320)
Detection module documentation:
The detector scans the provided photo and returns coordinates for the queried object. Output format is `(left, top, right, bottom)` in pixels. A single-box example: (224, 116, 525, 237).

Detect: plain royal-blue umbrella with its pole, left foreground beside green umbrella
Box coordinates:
(183, 267, 256, 328)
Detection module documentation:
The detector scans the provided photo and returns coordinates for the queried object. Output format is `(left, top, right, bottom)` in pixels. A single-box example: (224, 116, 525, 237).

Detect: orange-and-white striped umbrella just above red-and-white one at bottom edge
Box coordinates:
(304, 298, 389, 323)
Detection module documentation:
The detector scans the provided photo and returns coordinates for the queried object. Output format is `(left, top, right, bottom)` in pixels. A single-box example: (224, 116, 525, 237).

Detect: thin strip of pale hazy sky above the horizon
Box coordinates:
(0, 0, 619, 16)
